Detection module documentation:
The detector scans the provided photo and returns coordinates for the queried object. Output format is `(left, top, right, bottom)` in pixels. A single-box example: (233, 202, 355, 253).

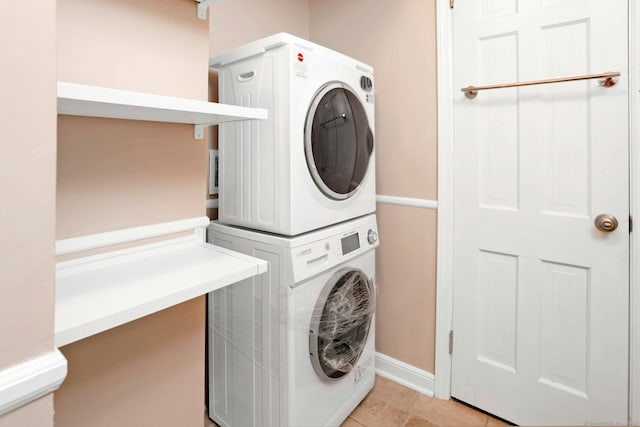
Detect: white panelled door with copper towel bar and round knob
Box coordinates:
(452, 0, 629, 425)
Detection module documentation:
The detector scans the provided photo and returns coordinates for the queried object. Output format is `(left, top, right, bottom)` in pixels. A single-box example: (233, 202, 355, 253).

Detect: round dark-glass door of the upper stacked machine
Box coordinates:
(305, 82, 373, 200)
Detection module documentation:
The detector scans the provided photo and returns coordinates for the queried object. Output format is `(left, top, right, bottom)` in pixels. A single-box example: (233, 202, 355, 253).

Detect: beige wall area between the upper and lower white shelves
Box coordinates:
(57, 116, 207, 239)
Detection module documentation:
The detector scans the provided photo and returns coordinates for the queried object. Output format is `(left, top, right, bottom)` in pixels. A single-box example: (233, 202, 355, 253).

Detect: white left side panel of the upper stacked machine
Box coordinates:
(219, 46, 289, 234)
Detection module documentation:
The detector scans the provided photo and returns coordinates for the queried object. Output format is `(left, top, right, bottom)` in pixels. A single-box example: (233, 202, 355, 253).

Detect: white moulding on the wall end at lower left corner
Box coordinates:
(0, 349, 67, 417)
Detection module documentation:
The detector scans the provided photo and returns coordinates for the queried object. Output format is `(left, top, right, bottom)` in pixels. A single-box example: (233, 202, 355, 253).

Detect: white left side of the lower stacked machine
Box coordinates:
(208, 234, 287, 427)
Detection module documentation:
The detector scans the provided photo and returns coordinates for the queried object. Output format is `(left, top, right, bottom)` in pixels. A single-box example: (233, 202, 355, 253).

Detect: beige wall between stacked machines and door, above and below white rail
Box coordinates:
(309, 0, 437, 372)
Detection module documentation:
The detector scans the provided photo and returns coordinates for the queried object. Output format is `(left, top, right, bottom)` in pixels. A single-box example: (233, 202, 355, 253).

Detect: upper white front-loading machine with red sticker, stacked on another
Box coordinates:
(209, 33, 376, 236)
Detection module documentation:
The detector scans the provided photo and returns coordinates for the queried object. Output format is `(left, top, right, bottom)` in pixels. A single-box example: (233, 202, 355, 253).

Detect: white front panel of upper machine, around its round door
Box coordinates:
(289, 51, 376, 235)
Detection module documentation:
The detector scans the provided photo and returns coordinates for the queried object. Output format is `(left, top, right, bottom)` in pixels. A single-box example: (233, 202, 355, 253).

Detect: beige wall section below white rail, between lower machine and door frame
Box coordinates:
(376, 204, 436, 373)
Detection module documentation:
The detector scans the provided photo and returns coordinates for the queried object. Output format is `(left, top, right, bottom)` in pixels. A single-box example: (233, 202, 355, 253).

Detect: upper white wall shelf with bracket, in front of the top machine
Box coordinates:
(58, 82, 268, 139)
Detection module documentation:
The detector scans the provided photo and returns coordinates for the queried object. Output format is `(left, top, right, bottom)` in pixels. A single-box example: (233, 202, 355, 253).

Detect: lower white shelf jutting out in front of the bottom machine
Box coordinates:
(55, 237, 267, 347)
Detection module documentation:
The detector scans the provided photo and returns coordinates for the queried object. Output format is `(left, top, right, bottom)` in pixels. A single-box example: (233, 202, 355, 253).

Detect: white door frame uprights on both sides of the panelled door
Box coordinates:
(435, 0, 640, 424)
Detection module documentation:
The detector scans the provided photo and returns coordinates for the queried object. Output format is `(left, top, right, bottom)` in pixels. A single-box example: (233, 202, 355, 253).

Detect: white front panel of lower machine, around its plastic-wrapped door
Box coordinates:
(287, 250, 375, 427)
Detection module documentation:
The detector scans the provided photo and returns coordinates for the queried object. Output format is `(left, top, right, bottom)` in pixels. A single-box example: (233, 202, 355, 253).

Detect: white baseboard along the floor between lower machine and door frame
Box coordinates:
(376, 353, 436, 397)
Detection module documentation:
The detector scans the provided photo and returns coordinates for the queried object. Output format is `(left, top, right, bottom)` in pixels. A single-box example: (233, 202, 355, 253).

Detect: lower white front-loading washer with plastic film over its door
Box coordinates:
(208, 215, 378, 427)
